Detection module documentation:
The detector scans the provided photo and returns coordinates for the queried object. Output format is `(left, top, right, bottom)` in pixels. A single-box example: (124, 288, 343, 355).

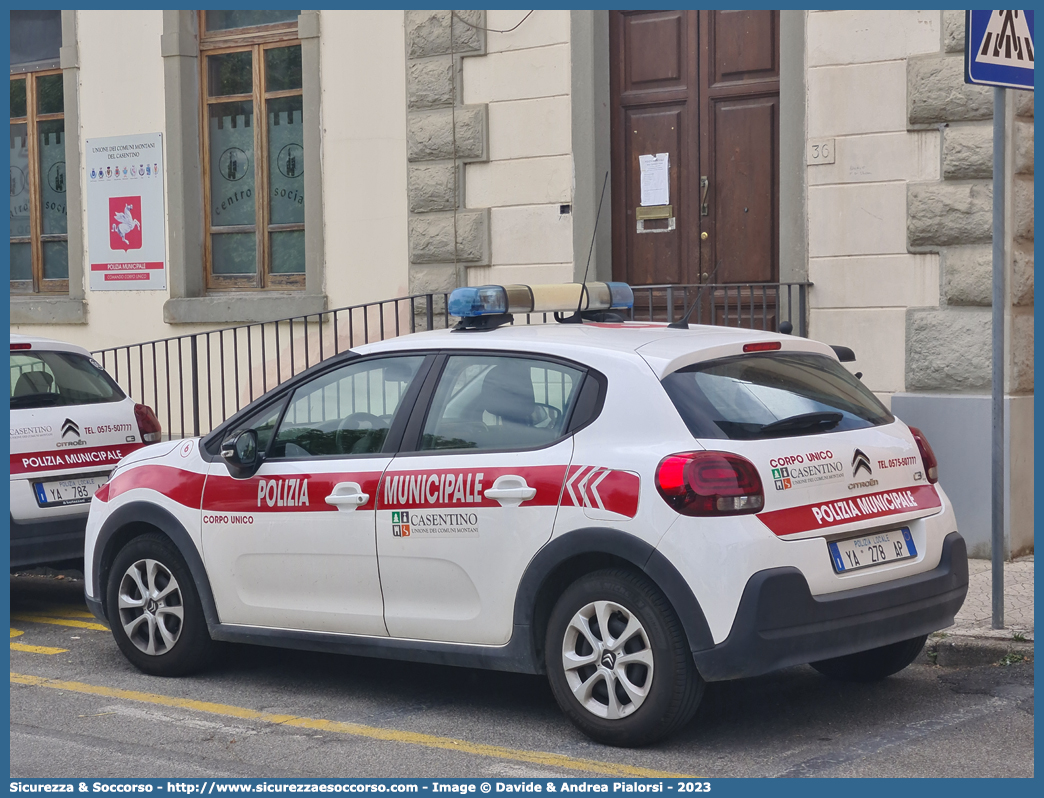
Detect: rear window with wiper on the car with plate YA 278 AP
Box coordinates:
(663, 352, 895, 441)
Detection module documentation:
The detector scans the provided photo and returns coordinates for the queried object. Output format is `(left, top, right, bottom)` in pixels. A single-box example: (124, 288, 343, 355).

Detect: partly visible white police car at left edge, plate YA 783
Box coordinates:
(10, 334, 160, 567)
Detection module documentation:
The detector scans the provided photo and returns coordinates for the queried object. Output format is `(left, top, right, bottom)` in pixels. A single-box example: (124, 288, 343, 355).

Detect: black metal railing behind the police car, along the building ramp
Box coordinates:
(93, 282, 811, 438)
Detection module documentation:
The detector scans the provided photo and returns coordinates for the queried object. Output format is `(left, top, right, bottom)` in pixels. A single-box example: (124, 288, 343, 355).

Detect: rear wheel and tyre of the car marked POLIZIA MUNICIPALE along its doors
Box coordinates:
(544, 569, 704, 747)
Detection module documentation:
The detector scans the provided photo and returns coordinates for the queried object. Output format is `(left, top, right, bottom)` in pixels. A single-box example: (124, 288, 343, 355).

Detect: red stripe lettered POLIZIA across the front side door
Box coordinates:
(203, 471, 381, 513)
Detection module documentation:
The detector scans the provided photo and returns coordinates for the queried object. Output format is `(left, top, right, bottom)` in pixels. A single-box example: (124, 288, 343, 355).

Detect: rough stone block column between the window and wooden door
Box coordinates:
(405, 10, 490, 294)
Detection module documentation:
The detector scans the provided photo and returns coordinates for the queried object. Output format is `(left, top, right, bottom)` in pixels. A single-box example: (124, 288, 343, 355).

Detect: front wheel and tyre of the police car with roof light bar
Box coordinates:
(105, 533, 214, 676)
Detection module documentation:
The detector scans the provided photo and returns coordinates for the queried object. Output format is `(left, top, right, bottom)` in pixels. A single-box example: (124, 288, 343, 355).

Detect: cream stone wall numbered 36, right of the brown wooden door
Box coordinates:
(783, 10, 1034, 557)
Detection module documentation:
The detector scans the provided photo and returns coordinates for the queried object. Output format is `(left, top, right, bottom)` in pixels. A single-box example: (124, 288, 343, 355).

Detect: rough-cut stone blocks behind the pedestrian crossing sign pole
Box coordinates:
(906, 11, 1034, 394)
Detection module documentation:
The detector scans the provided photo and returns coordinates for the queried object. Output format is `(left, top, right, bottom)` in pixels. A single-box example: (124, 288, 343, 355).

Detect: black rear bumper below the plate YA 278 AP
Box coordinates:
(692, 532, 968, 681)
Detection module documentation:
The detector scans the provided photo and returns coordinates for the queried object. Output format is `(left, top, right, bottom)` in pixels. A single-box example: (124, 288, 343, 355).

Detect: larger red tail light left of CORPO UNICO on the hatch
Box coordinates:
(656, 451, 765, 516)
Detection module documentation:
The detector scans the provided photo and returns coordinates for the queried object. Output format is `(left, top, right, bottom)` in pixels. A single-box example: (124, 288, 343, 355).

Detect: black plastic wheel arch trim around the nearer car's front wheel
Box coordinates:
(91, 501, 219, 628)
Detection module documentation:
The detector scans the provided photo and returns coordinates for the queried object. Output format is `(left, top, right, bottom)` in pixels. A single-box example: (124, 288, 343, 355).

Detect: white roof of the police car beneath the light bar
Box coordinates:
(353, 322, 836, 378)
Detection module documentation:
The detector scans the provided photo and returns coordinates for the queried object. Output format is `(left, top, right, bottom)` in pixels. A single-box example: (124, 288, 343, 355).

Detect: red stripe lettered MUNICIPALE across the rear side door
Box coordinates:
(378, 466, 566, 510)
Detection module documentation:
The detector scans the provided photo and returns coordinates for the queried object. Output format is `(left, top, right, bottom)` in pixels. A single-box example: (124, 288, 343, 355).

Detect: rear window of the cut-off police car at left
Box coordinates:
(10, 351, 124, 410)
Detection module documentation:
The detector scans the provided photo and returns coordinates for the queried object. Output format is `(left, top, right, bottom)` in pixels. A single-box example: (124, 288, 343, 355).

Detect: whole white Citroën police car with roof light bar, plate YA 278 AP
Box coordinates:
(86, 283, 968, 745)
